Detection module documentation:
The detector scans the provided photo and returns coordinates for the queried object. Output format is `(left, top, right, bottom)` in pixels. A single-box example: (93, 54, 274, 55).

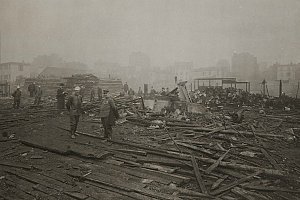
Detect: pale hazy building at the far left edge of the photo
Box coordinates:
(0, 62, 36, 83)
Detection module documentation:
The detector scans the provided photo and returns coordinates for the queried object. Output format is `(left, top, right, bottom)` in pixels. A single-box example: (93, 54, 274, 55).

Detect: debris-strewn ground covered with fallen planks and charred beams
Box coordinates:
(0, 96, 300, 199)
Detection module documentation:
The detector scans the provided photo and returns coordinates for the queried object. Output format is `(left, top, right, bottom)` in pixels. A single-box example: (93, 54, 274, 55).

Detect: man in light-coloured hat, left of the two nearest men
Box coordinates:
(66, 86, 82, 139)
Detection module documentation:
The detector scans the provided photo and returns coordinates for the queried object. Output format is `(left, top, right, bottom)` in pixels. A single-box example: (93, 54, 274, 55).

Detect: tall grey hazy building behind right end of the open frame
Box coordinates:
(231, 53, 259, 81)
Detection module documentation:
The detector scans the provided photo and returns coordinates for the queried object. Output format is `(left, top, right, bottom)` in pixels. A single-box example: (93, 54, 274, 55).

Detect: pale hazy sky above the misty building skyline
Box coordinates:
(0, 0, 300, 66)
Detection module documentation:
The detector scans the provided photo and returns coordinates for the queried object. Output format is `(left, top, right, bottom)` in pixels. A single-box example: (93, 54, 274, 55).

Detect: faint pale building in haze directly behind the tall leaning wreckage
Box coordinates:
(171, 62, 193, 82)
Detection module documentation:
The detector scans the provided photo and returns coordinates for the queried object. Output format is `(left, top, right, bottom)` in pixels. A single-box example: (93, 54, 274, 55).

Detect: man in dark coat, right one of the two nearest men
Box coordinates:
(100, 89, 119, 140)
